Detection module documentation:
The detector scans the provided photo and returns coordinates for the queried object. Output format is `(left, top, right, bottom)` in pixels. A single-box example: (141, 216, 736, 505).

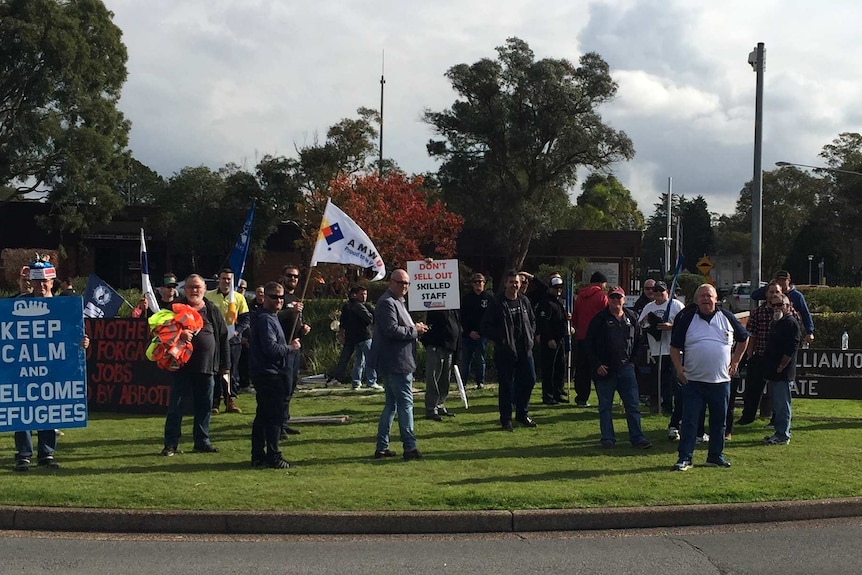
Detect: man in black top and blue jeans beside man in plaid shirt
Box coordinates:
(763, 293, 801, 445)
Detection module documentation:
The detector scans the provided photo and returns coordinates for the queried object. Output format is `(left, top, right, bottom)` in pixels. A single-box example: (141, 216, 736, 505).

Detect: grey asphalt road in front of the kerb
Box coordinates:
(0, 518, 862, 575)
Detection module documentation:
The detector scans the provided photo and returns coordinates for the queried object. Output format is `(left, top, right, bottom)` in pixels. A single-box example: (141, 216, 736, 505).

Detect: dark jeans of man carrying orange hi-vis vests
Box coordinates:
(165, 370, 215, 449)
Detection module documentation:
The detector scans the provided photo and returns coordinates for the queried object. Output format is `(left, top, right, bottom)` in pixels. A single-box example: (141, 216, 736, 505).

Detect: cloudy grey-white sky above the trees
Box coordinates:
(105, 0, 862, 216)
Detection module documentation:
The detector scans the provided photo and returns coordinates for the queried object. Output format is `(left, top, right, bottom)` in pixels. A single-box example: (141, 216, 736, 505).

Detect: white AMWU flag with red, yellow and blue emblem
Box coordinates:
(311, 200, 386, 281)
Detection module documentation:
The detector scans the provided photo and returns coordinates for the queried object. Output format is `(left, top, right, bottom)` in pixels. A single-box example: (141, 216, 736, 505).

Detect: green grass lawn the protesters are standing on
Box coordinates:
(0, 384, 862, 510)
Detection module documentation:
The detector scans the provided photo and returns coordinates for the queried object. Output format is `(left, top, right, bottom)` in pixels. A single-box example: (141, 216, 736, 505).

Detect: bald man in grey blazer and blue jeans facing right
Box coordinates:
(370, 269, 428, 460)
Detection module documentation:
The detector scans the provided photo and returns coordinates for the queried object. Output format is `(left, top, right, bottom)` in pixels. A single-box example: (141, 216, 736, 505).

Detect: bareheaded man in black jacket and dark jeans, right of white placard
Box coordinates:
(481, 270, 537, 431)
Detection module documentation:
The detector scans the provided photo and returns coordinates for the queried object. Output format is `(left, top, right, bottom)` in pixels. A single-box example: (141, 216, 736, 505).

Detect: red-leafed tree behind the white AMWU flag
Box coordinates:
(309, 171, 464, 269)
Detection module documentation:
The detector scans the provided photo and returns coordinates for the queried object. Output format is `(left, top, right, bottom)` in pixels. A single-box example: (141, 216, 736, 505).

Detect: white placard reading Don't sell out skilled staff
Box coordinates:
(407, 260, 461, 311)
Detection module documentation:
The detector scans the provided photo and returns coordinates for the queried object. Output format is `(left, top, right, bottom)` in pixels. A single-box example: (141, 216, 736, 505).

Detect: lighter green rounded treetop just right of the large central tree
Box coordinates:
(571, 174, 644, 230)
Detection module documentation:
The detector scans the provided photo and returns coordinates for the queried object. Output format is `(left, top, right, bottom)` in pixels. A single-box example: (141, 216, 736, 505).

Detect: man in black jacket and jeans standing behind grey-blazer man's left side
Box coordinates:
(326, 285, 383, 390)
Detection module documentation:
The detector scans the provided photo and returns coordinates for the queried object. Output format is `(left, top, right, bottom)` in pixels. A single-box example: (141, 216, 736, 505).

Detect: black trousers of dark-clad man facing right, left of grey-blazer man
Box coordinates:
(251, 374, 288, 463)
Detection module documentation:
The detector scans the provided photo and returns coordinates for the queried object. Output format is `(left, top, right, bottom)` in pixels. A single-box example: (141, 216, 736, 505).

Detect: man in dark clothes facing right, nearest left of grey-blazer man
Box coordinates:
(249, 282, 299, 469)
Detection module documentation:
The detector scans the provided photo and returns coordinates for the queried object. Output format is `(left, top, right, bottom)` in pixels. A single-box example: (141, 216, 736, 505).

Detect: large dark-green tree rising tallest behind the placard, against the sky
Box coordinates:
(424, 38, 634, 268)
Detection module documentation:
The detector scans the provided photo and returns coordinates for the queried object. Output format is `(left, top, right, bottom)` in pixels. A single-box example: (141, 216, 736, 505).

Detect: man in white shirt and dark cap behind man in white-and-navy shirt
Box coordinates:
(638, 281, 684, 441)
